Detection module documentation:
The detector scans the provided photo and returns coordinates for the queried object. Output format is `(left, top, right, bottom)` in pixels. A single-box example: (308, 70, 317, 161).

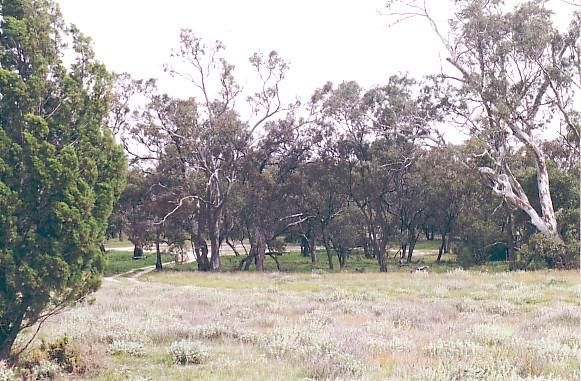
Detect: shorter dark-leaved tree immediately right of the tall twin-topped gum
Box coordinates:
(233, 113, 312, 271)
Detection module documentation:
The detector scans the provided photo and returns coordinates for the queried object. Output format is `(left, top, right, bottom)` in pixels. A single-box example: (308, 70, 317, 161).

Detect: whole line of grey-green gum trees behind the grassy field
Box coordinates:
(109, 1, 581, 271)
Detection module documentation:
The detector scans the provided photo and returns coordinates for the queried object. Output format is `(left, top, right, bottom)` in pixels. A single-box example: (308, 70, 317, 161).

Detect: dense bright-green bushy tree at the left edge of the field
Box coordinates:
(0, 0, 126, 359)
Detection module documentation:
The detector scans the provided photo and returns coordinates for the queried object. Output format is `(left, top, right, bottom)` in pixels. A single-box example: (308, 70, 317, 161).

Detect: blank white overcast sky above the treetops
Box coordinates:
(57, 0, 581, 123)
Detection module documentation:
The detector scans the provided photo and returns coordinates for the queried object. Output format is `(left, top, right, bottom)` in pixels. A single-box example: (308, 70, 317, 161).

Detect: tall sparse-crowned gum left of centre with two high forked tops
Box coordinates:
(122, 30, 287, 271)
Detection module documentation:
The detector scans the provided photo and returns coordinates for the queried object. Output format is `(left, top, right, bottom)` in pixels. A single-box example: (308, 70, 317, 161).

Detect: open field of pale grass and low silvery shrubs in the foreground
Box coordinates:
(27, 270, 581, 381)
